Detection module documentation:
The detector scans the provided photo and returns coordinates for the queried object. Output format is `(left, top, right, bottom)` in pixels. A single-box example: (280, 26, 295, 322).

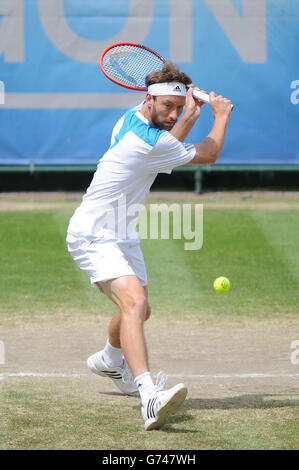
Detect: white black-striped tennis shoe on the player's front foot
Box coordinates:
(141, 384, 188, 431)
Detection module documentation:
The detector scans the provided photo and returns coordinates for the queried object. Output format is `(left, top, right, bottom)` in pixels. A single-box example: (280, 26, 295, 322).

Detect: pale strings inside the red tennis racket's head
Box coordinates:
(103, 45, 163, 89)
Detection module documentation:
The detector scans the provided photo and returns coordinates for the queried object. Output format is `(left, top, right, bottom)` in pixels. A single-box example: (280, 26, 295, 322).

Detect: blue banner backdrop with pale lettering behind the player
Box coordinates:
(0, 0, 299, 165)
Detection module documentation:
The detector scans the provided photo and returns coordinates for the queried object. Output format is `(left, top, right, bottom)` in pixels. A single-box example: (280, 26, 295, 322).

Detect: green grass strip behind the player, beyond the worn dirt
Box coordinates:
(0, 210, 299, 321)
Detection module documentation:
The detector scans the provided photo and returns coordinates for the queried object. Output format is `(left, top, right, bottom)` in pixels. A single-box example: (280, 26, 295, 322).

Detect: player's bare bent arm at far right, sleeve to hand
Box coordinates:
(188, 92, 231, 165)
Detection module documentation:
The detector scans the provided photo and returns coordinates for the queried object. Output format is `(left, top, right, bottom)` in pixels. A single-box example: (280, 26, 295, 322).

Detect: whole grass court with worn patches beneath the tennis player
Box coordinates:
(0, 196, 299, 449)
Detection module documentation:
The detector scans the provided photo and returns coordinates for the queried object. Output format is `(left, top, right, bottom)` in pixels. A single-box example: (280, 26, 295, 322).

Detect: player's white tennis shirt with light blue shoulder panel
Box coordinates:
(68, 103, 196, 241)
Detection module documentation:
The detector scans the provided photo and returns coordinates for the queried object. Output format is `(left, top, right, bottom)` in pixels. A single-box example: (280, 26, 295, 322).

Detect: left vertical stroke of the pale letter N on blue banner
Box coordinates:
(169, 0, 192, 62)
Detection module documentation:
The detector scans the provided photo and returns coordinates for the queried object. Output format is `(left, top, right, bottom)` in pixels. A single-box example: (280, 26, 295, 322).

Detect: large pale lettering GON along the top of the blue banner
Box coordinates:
(0, 0, 267, 63)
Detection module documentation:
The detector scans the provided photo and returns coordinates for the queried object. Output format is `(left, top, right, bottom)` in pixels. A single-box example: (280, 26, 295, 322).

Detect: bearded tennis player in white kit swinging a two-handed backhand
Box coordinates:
(67, 62, 231, 430)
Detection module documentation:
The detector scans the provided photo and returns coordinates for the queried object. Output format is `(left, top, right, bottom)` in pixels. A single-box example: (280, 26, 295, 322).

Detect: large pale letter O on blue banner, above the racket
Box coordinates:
(38, 0, 155, 64)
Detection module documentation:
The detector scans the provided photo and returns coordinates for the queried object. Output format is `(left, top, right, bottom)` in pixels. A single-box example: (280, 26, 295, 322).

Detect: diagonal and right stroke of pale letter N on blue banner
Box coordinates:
(205, 0, 267, 63)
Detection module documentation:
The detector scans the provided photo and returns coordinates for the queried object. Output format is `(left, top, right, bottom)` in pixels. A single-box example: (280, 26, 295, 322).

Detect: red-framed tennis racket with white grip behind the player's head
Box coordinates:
(100, 42, 234, 110)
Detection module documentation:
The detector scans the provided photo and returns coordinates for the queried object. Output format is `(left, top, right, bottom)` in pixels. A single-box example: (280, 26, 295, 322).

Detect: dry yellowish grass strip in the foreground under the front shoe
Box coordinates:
(0, 378, 299, 450)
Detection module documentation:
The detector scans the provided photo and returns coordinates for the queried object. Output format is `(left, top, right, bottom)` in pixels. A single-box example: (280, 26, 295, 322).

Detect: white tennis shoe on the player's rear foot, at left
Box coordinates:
(87, 351, 139, 396)
